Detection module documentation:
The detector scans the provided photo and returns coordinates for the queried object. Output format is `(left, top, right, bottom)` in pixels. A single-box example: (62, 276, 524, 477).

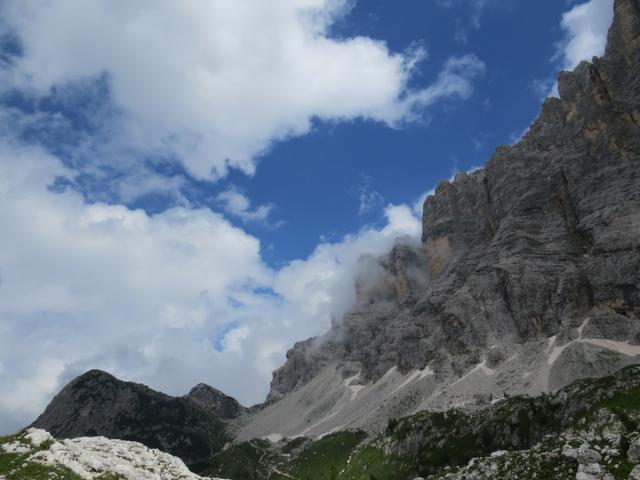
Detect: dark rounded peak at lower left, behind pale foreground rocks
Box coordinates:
(32, 370, 226, 466)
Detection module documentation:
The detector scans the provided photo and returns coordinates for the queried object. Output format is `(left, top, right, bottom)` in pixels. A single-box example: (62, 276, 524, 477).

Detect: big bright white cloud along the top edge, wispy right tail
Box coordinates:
(0, 0, 480, 178)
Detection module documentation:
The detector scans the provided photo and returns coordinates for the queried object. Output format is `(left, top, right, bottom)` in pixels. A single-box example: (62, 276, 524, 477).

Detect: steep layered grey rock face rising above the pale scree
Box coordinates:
(269, 0, 640, 400)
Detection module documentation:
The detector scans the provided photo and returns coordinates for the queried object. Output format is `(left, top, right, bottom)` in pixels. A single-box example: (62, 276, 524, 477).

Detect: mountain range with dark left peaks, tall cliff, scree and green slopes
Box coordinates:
(23, 0, 640, 480)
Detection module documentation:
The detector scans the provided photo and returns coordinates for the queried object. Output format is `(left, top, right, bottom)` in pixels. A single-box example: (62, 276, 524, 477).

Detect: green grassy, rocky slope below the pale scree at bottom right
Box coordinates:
(196, 367, 640, 480)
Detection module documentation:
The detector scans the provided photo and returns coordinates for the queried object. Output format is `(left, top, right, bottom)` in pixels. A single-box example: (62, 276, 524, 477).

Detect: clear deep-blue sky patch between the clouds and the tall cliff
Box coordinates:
(152, 0, 596, 267)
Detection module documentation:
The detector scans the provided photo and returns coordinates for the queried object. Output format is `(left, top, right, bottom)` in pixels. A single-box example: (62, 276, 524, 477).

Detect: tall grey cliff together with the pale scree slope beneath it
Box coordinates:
(239, 0, 640, 440)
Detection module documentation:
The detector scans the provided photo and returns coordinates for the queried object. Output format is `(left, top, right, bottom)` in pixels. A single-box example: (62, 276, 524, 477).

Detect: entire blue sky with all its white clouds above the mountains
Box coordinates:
(0, 0, 612, 433)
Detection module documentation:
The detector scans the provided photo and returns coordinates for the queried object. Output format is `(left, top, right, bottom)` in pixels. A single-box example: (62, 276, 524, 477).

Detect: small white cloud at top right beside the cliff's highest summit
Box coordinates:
(557, 0, 613, 70)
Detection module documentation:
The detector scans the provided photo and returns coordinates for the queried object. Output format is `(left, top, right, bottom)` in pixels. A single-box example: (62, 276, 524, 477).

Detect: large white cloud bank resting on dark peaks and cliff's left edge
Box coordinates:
(0, 145, 420, 432)
